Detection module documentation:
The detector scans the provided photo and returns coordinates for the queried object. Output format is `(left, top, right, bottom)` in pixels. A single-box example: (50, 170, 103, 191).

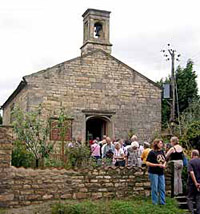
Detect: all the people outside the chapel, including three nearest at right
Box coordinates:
(90, 135, 200, 211)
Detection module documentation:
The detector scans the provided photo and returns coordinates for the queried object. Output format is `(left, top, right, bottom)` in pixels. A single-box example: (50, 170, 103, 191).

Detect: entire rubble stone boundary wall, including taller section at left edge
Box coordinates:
(0, 128, 171, 207)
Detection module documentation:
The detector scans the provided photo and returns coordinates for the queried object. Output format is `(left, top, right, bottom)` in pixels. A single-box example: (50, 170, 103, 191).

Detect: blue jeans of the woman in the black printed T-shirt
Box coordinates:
(149, 173, 165, 205)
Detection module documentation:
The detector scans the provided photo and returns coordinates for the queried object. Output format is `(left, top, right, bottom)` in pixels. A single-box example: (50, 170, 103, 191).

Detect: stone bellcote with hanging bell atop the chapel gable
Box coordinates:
(81, 9, 112, 55)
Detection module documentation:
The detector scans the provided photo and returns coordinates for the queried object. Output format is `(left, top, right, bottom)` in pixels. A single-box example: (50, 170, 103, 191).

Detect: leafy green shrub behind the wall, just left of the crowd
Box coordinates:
(65, 145, 90, 168)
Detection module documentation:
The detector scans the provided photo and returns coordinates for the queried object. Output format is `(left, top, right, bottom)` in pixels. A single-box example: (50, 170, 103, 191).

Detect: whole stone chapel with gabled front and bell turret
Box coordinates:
(1, 9, 161, 141)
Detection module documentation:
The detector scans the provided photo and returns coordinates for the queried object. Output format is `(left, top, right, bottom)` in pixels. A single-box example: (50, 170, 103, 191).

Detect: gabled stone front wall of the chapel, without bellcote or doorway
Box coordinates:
(6, 51, 161, 140)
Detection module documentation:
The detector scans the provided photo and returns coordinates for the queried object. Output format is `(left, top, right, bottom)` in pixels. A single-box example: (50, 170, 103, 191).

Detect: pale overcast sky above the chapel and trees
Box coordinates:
(0, 0, 200, 105)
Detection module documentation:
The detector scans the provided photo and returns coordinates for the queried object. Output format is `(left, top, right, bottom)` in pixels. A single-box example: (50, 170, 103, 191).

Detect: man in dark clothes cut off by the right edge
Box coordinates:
(187, 150, 200, 214)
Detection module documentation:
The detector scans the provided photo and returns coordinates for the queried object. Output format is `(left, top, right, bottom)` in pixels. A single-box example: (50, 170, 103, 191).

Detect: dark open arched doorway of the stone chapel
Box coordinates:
(86, 116, 109, 142)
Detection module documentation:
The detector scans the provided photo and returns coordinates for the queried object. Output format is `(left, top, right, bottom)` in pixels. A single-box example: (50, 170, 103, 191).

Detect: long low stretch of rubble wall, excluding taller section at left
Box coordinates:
(7, 167, 150, 207)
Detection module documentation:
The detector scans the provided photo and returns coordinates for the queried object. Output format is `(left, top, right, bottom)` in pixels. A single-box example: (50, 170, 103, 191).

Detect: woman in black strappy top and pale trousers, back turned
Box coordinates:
(166, 137, 183, 195)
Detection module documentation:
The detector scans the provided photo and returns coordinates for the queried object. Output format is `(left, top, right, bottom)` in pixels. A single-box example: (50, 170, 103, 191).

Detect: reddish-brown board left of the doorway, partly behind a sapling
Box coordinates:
(50, 118, 73, 141)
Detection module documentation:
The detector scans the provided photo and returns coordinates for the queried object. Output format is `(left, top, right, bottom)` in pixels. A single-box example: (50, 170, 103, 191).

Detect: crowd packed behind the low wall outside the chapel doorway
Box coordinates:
(90, 135, 150, 167)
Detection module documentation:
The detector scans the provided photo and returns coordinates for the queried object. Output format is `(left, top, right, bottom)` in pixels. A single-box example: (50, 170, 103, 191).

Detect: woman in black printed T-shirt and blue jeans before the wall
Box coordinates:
(146, 139, 166, 205)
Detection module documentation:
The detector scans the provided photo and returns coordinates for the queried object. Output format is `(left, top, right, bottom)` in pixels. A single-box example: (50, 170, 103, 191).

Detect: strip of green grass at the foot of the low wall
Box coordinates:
(52, 198, 184, 214)
